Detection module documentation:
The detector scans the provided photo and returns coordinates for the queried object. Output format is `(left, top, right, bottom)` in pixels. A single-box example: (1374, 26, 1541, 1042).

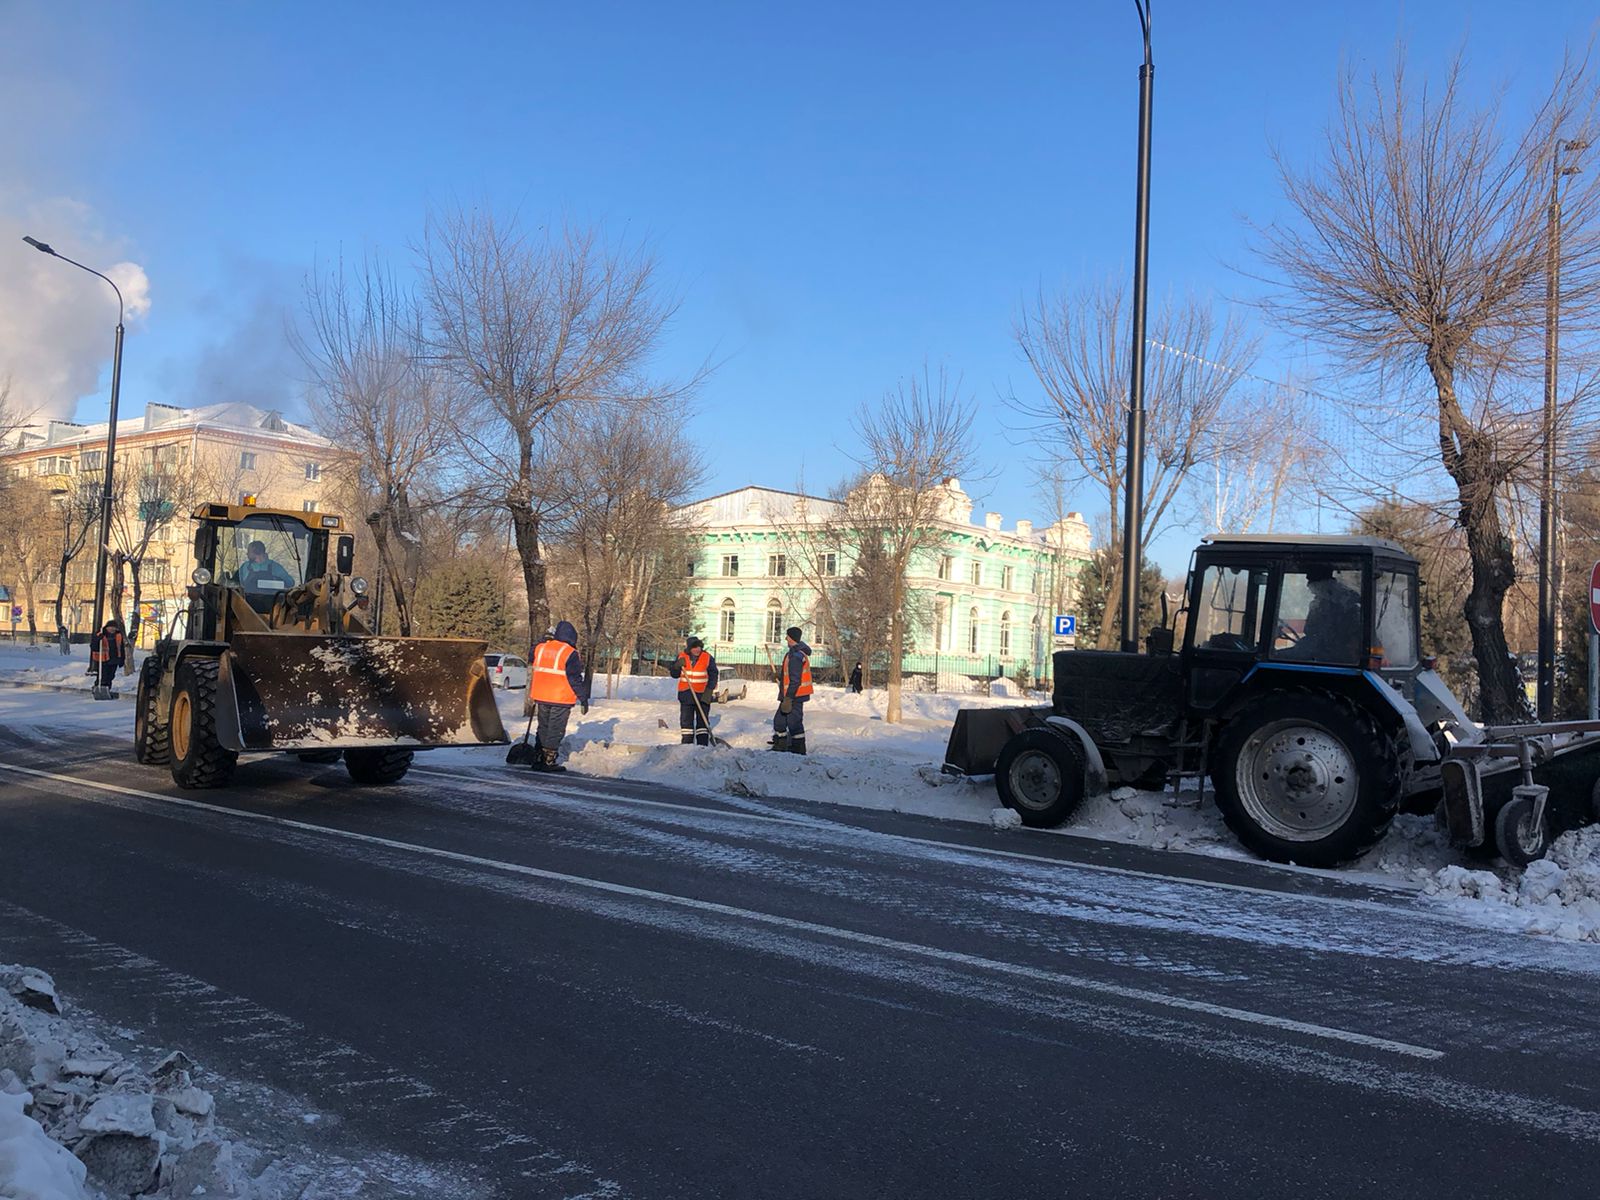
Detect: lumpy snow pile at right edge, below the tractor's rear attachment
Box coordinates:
(1427, 826, 1600, 942)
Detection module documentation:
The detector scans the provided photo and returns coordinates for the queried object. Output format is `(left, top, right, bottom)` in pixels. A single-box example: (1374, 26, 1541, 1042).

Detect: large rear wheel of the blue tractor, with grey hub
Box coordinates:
(1211, 691, 1405, 867)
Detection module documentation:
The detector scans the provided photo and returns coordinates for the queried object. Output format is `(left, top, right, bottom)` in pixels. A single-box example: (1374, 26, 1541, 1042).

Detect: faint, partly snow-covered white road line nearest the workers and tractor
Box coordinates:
(411, 766, 1427, 925)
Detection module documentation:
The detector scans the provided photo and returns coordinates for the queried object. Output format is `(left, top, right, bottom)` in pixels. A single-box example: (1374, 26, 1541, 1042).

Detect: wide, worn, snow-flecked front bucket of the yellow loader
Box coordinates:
(218, 632, 509, 750)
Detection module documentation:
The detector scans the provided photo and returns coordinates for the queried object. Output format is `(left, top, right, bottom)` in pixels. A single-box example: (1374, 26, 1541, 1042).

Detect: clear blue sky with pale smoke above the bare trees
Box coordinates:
(0, 0, 1595, 566)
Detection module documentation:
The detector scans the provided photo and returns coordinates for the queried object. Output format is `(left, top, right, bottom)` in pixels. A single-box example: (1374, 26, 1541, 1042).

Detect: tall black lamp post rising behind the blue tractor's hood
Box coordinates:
(1122, 0, 1155, 653)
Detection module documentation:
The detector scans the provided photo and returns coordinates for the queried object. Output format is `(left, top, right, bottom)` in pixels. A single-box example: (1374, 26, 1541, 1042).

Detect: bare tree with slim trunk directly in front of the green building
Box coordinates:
(843, 366, 976, 725)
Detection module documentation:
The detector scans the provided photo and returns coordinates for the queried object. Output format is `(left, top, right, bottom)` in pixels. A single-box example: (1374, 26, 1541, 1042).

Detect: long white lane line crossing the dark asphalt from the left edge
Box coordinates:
(0, 763, 1445, 1059)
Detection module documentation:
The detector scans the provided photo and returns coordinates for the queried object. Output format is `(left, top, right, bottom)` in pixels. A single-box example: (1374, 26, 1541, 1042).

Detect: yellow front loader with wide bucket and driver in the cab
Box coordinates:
(134, 502, 507, 787)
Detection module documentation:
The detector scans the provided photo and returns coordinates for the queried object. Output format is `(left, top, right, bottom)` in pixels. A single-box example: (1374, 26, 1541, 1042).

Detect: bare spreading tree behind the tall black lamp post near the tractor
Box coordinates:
(1010, 283, 1254, 650)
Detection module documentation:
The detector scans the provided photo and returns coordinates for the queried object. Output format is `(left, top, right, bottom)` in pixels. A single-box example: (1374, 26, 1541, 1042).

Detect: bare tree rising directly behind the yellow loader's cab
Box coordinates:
(294, 259, 470, 637)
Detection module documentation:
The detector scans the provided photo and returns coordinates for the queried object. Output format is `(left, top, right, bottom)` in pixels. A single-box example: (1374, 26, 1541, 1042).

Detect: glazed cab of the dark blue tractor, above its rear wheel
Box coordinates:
(1182, 534, 1421, 714)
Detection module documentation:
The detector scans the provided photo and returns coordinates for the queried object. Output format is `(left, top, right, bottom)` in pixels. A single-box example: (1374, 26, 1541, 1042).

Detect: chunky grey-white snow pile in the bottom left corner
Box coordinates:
(0, 966, 309, 1200)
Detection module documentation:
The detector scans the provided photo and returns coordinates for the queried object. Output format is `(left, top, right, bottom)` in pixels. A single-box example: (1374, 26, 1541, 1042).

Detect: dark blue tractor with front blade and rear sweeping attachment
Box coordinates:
(946, 534, 1600, 867)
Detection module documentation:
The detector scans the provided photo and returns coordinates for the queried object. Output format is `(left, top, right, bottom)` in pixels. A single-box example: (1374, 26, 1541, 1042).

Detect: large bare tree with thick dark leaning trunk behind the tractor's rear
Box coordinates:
(1262, 51, 1600, 720)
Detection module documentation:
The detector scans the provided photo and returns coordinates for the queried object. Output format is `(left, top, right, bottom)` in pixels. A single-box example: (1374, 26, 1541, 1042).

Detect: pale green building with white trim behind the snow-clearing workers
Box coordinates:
(682, 480, 1090, 688)
